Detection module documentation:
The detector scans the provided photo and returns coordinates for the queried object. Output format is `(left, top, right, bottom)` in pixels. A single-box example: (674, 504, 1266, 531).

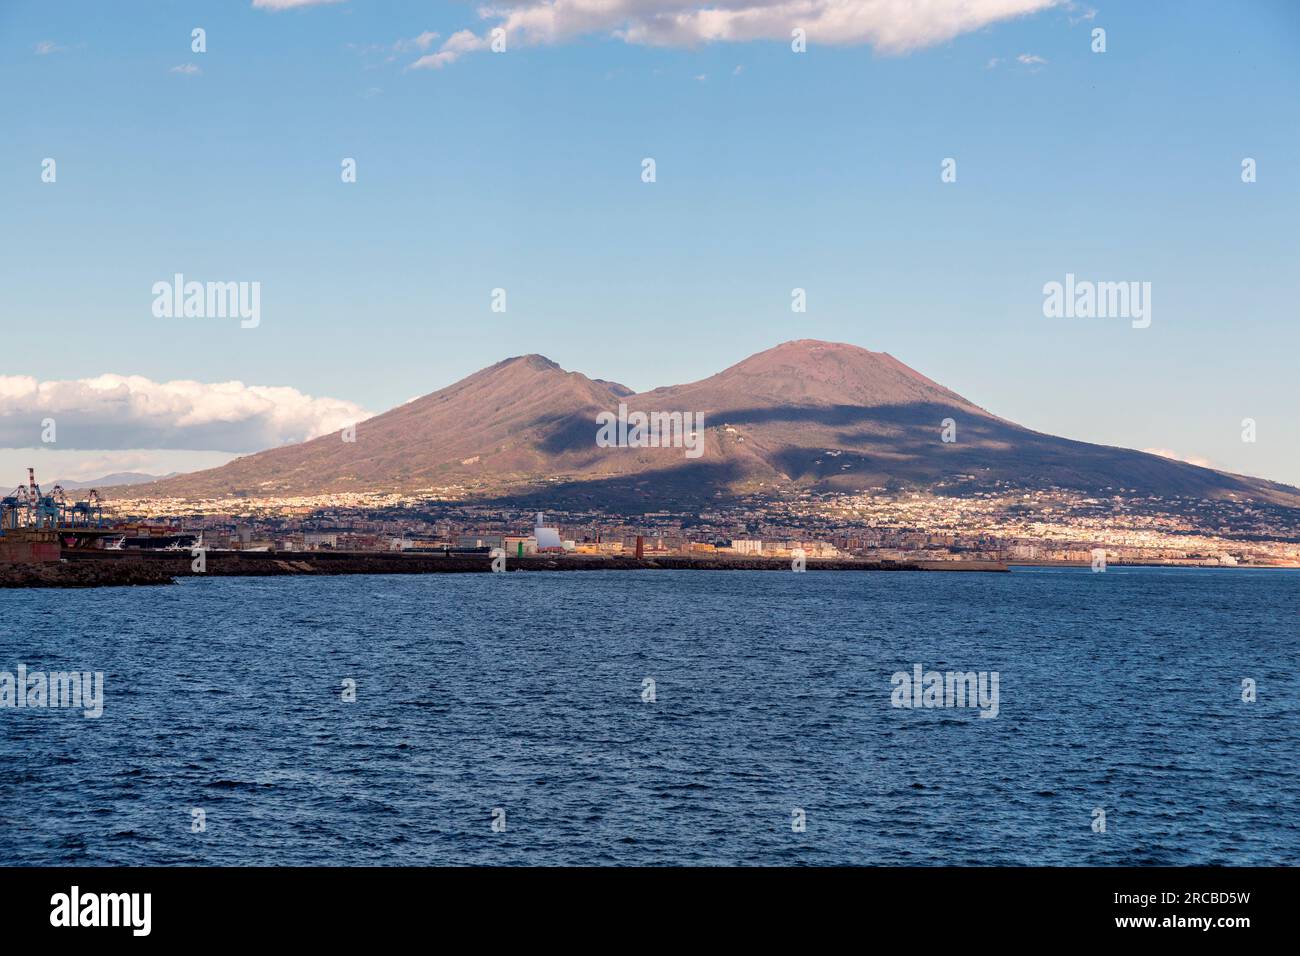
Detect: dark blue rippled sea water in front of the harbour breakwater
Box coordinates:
(0, 567, 1300, 865)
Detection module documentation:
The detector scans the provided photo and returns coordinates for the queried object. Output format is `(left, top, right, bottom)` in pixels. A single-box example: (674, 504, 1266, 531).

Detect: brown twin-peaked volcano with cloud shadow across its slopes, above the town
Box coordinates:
(121, 339, 1300, 510)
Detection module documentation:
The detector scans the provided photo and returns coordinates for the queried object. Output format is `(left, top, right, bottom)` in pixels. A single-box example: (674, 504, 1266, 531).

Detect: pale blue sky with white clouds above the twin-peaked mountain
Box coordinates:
(0, 0, 1300, 485)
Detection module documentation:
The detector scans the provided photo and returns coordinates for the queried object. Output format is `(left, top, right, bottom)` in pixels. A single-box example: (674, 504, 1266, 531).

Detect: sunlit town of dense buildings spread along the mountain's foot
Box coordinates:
(106, 481, 1300, 567)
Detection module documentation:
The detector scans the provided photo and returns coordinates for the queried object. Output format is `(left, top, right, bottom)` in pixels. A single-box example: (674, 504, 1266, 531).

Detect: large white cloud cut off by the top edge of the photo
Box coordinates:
(412, 0, 1061, 69)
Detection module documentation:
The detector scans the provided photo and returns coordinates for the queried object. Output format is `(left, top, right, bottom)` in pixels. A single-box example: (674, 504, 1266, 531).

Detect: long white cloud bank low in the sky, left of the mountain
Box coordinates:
(0, 375, 371, 453)
